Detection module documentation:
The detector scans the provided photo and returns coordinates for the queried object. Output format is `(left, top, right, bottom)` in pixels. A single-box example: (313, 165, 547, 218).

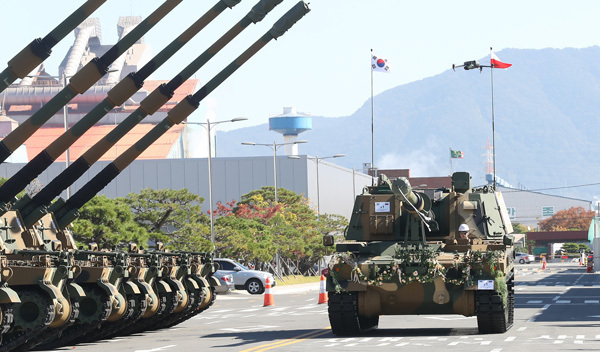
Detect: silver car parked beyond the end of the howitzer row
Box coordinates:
(214, 258, 277, 295)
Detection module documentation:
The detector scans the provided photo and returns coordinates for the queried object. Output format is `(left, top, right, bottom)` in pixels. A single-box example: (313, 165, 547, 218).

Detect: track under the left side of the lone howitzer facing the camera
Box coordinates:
(328, 292, 379, 336)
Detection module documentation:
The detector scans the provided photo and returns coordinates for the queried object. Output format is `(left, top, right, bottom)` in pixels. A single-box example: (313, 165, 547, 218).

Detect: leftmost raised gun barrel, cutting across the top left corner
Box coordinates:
(0, 0, 106, 92)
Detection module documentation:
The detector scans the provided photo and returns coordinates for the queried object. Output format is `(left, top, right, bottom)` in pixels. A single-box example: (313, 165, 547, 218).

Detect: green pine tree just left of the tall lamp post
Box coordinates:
(123, 188, 212, 251)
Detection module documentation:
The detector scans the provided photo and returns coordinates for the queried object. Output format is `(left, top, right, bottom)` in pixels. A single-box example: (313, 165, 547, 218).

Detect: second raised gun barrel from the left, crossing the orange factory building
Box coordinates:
(0, 0, 183, 162)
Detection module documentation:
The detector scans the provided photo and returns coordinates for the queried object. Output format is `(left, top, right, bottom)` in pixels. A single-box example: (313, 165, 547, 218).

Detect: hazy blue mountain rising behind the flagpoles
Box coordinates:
(217, 46, 600, 200)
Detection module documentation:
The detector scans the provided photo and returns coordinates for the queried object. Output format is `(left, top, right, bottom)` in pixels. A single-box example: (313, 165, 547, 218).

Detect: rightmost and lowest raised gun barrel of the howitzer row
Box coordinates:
(50, 1, 310, 228)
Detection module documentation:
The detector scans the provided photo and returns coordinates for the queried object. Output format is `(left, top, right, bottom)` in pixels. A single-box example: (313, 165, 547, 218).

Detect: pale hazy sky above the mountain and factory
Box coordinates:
(0, 0, 600, 129)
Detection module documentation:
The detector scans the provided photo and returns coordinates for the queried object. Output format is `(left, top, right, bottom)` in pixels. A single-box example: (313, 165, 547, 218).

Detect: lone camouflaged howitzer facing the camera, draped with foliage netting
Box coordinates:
(324, 172, 514, 335)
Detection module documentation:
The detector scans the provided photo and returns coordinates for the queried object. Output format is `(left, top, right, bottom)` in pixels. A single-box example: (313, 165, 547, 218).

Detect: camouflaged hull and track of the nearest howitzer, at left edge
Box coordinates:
(0, 211, 85, 350)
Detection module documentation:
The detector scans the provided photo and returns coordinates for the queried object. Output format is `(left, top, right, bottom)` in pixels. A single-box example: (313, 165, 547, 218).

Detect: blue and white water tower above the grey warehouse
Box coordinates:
(269, 107, 312, 155)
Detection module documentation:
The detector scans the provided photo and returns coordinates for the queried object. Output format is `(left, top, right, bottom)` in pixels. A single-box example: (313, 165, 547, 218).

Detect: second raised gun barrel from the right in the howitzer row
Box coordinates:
(18, 0, 282, 224)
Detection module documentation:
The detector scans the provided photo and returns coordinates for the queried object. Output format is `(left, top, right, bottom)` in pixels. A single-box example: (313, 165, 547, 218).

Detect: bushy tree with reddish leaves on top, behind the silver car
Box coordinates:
(215, 187, 330, 267)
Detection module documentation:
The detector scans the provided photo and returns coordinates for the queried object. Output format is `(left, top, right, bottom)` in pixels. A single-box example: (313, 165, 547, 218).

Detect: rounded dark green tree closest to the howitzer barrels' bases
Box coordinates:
(72, 195, 148, 249)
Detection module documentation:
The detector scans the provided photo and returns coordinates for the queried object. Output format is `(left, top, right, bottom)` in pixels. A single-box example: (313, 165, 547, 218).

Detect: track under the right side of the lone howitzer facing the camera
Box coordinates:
(475, 276, 515, 334)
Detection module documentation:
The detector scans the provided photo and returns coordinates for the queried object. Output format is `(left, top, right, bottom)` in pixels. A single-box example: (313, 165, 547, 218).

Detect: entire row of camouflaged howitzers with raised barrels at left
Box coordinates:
(0, 0, 310, 351)
